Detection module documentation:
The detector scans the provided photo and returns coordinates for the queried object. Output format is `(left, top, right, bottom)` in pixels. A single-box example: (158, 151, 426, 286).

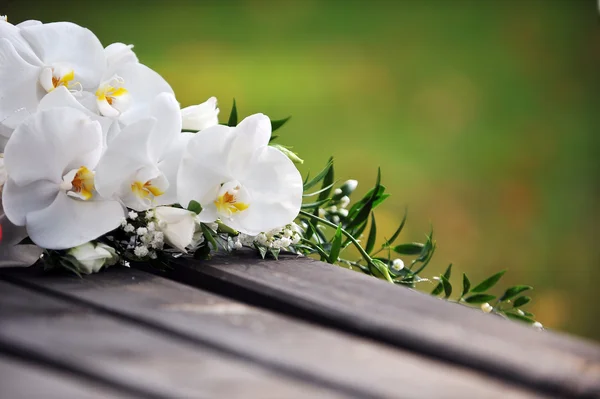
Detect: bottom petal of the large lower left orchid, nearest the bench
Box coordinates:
(27, 191, 125, 249)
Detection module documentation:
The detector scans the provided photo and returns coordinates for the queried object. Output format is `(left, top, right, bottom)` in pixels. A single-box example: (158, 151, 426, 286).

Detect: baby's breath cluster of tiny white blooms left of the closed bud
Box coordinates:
(121, 210, 165, 259)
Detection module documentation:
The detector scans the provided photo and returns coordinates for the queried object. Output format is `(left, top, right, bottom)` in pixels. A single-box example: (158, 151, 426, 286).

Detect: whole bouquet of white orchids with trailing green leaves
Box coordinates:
(0, 17, 539, 326)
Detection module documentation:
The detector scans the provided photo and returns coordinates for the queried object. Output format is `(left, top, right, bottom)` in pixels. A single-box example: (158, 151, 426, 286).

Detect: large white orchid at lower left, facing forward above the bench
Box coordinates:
(2, 108, 125, 249)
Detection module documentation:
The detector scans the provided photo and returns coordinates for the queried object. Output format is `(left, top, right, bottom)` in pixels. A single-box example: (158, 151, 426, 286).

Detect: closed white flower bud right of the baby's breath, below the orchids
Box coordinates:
(154, 206, 196, 252)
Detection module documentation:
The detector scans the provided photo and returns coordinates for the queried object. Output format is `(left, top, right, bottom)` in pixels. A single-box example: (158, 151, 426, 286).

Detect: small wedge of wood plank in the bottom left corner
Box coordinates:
(0, 355, 134, 399)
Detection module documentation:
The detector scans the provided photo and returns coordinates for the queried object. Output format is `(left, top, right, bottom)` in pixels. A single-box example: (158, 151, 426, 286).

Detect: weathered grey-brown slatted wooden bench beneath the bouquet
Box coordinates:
(0, 251, 600, 399)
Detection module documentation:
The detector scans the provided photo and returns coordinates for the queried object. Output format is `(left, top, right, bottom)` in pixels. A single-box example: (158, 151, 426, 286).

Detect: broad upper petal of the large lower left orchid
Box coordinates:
(4, 107, 102, 185)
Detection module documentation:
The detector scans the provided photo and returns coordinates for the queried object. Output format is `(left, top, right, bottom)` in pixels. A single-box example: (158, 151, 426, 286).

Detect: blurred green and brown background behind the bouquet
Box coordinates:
(5, 0, 600, 340)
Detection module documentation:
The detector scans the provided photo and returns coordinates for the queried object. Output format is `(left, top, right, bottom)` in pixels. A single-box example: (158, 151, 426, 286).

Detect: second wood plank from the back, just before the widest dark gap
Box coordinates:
(0, 268, 552, 398)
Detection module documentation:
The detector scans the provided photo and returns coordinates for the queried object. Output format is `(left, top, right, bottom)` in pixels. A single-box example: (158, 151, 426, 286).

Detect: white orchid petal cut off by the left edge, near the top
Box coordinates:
(0, 38, 46, 129)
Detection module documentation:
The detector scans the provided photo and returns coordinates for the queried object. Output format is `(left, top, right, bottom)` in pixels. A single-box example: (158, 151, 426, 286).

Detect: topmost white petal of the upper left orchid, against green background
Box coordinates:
(21, 22, 106, 90)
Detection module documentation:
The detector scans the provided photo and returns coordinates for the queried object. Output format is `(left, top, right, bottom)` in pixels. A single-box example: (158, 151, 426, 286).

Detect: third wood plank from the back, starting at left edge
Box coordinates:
(0, 280, 344, 398)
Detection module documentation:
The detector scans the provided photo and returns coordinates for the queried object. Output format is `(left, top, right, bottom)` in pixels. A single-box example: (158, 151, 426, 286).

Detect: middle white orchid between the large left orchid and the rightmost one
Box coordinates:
(96, 93, 193, 211)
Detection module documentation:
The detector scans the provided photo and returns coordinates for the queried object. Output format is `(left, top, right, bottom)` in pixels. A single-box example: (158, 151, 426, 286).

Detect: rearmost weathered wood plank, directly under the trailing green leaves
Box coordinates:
(151, 251, 600, 398)
